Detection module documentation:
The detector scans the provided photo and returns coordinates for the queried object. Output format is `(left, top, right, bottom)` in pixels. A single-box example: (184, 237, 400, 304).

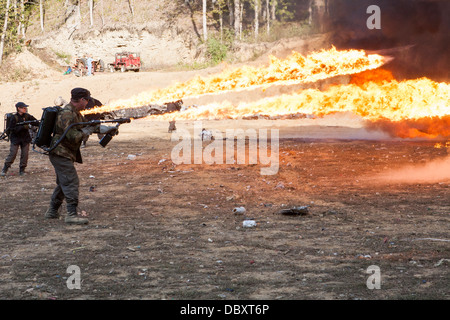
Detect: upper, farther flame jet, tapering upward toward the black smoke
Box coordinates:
(84, 47, 385, 114)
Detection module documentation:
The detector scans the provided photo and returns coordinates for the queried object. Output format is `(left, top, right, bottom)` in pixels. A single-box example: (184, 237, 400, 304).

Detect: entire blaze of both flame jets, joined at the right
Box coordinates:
(81, 47, 450, 138)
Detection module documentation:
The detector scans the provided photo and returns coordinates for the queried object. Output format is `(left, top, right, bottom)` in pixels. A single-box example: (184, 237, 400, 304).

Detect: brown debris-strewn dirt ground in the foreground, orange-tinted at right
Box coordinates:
(0, 119, 450, 300)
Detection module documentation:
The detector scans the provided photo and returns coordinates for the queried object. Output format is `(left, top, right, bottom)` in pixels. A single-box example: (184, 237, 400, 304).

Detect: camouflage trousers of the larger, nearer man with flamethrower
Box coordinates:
(49, 154, 80, 213)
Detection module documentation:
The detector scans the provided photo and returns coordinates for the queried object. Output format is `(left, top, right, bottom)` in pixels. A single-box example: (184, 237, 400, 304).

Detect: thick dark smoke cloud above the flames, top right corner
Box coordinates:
(327, 0, 450, 81)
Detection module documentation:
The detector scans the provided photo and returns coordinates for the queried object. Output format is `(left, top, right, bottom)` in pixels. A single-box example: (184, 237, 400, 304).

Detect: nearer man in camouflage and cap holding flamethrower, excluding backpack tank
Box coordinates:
(45, 88, 129, 224)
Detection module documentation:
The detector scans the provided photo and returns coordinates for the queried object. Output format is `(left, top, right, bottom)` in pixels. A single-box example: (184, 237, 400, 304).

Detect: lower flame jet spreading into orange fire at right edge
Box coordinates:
(156, 78, 450, 138)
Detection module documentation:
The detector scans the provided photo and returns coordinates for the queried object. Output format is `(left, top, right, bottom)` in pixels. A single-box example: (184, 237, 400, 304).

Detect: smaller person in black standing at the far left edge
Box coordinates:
(1, 102, 37, 176)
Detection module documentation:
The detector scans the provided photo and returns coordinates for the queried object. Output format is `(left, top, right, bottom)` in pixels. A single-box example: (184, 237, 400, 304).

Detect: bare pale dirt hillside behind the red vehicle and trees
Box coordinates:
(0, 0, 320, 81)
